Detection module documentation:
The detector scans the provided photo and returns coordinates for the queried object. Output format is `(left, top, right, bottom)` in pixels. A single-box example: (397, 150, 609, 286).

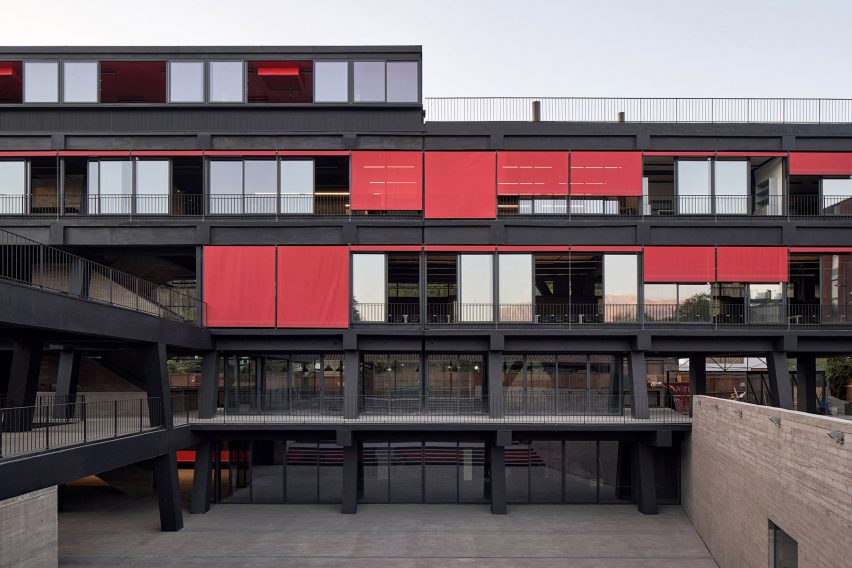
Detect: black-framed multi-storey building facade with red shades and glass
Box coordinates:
(0, 47, 852, 528)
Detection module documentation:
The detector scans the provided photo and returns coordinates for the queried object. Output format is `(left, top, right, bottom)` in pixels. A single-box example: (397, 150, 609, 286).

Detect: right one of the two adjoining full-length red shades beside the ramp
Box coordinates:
(278, 246, 349, 328)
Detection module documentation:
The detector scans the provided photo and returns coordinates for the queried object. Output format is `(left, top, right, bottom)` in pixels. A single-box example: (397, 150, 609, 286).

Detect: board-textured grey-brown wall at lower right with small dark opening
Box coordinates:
(681, 396, 852, 568)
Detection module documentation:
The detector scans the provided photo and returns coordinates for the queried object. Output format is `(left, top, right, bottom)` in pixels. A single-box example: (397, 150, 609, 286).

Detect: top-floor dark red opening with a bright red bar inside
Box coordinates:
(248, 61, 314, 103)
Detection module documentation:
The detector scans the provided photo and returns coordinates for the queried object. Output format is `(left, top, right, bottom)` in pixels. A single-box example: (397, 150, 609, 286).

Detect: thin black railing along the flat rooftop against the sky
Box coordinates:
(423, 97, 852, 124)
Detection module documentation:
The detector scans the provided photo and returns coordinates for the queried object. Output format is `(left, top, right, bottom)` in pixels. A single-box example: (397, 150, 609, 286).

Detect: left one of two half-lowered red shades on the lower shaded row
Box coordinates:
(643, 247, 716, 282)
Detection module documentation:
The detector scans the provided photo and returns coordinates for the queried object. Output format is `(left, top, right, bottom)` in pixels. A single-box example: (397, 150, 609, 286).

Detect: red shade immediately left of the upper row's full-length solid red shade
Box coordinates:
(350, 152, 423, 211)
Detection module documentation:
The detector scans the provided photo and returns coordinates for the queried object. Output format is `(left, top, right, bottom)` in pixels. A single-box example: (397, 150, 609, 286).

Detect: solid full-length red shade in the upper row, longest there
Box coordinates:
(425, 152, 497, 219)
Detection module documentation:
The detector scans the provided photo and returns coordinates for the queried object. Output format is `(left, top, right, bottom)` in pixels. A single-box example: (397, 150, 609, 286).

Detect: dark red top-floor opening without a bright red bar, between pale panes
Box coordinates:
(101, 61, 166, 103)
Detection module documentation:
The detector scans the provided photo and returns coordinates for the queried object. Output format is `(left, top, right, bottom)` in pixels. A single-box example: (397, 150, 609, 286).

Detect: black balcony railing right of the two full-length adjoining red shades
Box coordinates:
(352, 300, 852, 329)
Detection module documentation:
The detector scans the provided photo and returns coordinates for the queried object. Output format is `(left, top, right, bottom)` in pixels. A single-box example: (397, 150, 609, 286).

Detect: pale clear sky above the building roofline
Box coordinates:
(0, 0, 852, 98)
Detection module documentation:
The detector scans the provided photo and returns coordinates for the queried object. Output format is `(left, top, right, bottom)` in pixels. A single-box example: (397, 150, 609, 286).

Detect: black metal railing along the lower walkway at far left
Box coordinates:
(0, 397, 164, 459)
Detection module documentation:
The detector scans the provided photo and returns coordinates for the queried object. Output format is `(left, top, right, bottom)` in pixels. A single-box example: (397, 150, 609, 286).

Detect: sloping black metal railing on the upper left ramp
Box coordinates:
(0, 229, 205, 325)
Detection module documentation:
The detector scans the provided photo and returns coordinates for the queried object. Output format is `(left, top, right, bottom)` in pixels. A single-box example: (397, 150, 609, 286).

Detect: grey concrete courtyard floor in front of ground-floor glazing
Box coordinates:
(59, 486, 716, 568)
